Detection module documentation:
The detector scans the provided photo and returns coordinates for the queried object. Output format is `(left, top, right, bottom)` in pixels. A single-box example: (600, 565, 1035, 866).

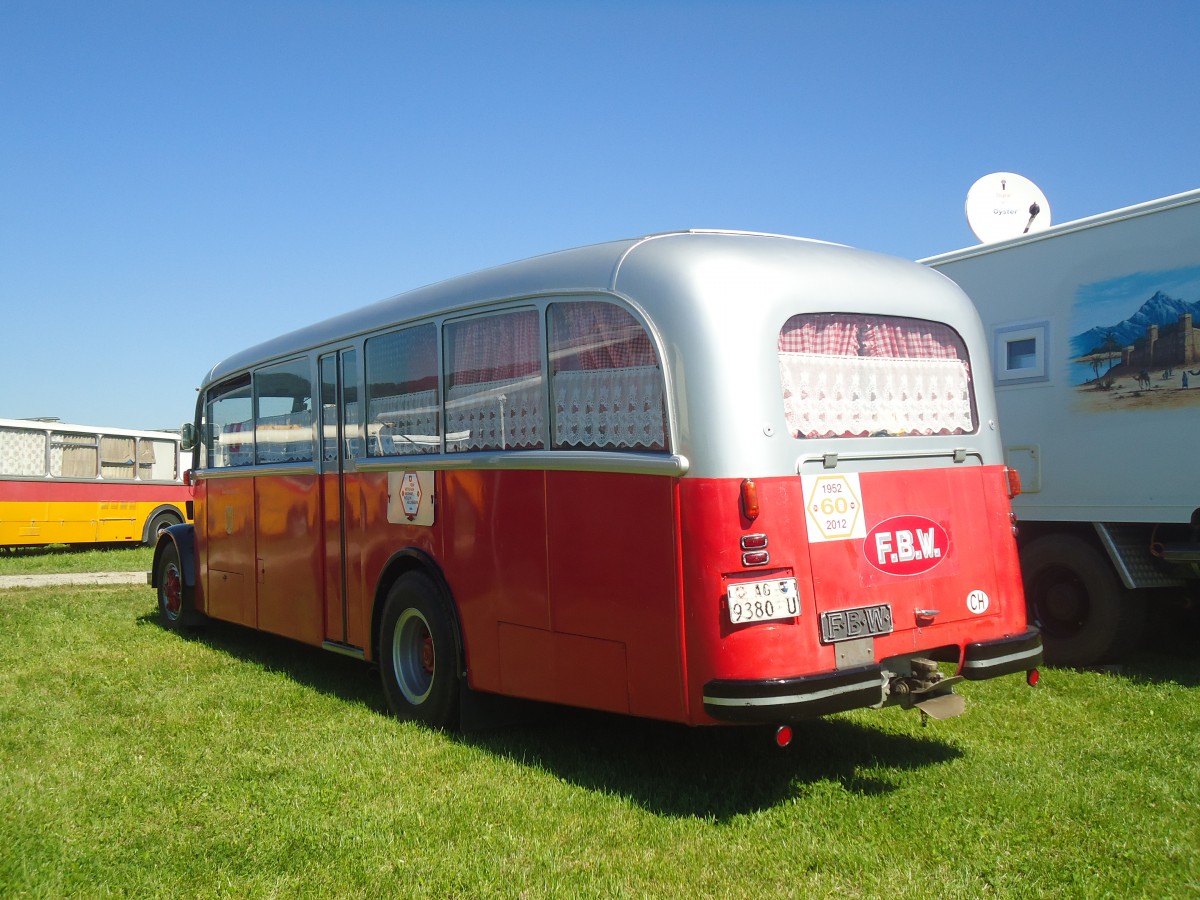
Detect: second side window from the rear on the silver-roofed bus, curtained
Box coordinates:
(444, 310, 546, 452)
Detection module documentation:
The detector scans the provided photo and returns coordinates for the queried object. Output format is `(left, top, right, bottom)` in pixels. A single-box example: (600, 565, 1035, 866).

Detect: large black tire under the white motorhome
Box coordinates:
(1021, 534, 1146, 666)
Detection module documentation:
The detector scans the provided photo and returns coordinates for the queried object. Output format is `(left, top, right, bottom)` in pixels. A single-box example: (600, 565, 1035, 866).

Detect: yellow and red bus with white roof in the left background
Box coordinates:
(0, 419, 190, 547)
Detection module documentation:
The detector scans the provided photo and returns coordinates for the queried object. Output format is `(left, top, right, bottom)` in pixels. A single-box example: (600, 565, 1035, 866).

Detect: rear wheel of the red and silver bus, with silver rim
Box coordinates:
(379, 572, 461, 728)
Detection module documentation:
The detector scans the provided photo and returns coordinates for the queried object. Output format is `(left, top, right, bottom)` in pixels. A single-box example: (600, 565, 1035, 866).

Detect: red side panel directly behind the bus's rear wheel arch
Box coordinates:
(437, 469, 553, 700)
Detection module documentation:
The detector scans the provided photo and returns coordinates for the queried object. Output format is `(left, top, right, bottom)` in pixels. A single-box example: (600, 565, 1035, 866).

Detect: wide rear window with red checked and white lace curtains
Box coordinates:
(779, 313, 976, 438)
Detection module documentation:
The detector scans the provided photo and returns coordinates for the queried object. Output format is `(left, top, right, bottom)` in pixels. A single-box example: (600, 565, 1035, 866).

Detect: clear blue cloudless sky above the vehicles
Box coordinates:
(0, 0, 1200, 427)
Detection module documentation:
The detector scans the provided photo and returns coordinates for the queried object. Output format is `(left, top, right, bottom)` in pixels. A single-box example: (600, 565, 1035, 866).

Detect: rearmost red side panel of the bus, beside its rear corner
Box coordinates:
(546, 472, 684, 720)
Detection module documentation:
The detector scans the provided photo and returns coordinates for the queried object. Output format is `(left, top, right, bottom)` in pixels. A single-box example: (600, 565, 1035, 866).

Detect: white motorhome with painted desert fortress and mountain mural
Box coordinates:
(922, 191, 1200, 665)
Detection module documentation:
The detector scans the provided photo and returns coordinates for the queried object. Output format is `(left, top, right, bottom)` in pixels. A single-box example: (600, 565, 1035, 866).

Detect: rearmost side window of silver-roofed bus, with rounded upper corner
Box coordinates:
(548, 300, 667, 451)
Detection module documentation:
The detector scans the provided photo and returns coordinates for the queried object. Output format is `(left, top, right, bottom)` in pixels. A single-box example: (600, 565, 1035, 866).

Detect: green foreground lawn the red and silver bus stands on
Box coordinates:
(0, 587, 1200, 898)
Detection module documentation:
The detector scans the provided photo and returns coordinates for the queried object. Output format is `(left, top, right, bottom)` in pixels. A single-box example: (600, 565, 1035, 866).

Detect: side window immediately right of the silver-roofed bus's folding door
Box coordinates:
(366, 325, 442, 456)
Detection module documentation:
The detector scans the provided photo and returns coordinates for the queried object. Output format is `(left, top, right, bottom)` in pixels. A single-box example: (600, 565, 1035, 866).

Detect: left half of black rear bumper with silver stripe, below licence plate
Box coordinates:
(704, 666, 887, 722)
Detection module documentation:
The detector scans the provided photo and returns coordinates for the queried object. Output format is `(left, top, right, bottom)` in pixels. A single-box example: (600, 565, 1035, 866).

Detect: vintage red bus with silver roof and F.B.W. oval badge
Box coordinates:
(149, 232, 1042, 743)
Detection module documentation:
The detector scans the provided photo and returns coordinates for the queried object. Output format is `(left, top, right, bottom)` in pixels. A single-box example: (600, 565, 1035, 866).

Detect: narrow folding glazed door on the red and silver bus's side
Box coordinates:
(319, 349, 361, 644)
